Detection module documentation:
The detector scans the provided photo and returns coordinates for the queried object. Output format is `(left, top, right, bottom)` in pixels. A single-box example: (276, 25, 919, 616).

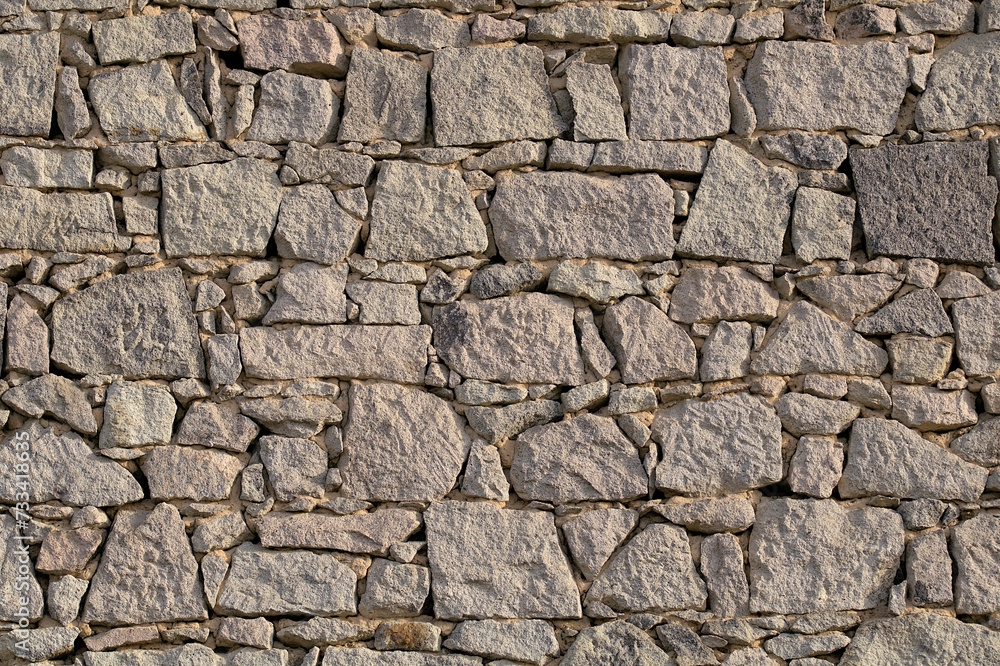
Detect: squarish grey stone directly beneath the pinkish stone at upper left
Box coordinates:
(249, 70, 340, 146)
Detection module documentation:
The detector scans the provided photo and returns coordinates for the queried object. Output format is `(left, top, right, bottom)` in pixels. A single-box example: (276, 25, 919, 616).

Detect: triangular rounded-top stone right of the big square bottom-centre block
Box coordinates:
(587, 523, 708, 613)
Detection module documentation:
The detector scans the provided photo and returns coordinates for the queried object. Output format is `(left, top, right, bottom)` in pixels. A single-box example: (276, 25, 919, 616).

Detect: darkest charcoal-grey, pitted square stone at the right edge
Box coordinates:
(850, 141, 997, 264)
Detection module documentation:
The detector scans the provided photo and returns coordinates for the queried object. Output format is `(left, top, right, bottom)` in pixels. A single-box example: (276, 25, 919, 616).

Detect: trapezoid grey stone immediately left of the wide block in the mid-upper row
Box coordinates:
(365, 161, 486, 261)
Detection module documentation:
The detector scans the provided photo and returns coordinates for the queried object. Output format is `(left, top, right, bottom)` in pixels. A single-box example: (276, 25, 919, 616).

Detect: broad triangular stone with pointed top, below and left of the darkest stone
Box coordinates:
(750, 301, 889, 377)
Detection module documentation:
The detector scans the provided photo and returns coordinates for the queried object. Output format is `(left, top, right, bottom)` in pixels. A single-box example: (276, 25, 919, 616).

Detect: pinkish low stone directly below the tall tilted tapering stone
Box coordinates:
(670, 266, 778, 324)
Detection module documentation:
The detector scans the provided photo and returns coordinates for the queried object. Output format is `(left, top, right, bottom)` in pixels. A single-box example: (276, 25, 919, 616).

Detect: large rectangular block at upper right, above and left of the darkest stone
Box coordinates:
(745, 40, 909, 135)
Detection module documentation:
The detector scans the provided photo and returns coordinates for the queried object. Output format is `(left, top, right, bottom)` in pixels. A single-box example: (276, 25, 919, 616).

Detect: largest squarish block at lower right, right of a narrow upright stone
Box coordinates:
(750, 498, 904, 613)
